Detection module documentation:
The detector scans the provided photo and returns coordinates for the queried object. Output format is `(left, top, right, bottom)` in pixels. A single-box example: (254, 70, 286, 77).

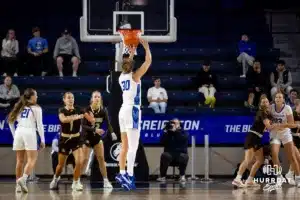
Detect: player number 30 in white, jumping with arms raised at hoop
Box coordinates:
(116, 40, 152, 190)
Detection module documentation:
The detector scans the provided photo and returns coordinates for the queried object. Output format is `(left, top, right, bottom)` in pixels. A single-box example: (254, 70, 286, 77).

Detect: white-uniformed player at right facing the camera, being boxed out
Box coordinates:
(264, 93, 300, 189)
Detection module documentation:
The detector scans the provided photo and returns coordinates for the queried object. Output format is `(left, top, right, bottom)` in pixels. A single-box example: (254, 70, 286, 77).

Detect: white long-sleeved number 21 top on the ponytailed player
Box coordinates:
(9, 106, 45, 143)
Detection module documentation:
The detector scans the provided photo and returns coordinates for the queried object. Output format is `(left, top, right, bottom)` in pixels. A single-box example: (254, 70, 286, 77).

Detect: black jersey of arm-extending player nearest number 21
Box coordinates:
(58, 107, 83, 134)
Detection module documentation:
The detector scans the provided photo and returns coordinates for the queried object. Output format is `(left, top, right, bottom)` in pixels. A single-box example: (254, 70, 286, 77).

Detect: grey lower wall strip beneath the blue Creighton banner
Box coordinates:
(0, 147, 288, 176)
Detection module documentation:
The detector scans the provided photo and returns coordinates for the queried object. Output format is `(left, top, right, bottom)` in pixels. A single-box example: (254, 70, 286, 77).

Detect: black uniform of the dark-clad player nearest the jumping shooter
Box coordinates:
(82, 106, 113, 148)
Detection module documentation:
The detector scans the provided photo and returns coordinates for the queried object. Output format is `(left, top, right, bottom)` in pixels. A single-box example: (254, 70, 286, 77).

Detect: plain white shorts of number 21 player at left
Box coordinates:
(13, 127, 38, 151)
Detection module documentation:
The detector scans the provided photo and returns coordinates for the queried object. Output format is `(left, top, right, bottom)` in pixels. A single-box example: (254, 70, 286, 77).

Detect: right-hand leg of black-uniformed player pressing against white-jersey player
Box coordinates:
(246, 148, 264, 187)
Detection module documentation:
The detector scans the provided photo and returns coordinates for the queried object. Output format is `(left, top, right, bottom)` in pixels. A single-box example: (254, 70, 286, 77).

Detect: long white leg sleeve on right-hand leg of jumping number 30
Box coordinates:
(127, 129, 140, 176)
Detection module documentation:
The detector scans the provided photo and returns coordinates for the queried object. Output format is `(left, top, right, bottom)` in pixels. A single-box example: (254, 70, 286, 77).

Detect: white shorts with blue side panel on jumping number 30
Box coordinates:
(119, 106, 141, 133)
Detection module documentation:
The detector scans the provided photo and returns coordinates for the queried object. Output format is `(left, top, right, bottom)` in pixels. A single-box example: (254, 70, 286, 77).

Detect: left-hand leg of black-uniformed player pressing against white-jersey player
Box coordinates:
(232, 148, 254, 187)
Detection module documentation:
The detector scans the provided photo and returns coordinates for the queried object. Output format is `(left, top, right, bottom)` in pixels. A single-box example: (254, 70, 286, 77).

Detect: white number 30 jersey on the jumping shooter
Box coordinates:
(119, 72, 142, 106)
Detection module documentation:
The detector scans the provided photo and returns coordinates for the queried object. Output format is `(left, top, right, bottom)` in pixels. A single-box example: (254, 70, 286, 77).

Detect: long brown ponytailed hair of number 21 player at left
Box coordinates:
(8, 88, 35, 124)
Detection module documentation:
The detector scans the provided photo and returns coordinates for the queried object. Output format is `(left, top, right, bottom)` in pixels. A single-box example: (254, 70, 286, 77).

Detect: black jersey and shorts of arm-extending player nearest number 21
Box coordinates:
(58, 107, 83, 155)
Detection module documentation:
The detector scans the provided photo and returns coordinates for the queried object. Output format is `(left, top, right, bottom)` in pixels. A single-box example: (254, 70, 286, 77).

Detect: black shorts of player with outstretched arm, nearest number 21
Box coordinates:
(58, 136, 82, 155)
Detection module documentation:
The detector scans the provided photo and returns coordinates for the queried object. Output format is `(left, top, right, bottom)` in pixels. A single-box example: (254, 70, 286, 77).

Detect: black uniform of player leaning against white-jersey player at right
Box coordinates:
(244, 110, 272, 151)
